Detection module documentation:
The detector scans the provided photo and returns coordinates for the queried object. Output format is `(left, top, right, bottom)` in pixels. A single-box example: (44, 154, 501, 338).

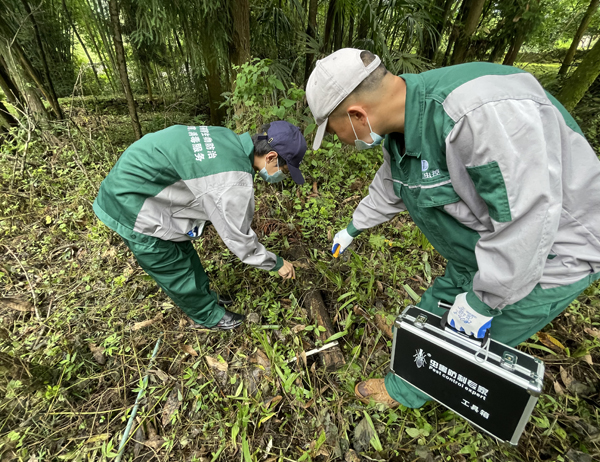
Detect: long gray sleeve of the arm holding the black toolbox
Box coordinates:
(444, 74, 569, 309)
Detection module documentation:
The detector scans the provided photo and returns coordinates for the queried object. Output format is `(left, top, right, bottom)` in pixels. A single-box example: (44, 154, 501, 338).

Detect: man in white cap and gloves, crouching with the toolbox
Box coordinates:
(306, 48, 600, 408)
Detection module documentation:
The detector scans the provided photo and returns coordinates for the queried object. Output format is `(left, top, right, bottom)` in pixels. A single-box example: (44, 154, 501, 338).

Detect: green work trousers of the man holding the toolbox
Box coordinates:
(385, 262, 600, 408)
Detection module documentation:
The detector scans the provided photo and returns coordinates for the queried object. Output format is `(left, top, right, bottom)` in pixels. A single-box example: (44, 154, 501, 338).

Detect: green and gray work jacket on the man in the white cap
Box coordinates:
(348, 63, 600, 316)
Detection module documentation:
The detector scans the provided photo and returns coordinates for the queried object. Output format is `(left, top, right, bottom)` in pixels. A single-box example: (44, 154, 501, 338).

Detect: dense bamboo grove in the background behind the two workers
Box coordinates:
(0, 0, 600, 138)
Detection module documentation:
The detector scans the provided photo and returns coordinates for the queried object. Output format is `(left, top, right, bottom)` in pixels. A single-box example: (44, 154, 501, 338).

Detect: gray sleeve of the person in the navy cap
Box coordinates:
(202, 172, 277, 270)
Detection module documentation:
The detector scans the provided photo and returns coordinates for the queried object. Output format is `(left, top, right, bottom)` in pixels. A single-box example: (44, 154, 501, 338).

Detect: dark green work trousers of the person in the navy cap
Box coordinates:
(121, 236, 225, 327)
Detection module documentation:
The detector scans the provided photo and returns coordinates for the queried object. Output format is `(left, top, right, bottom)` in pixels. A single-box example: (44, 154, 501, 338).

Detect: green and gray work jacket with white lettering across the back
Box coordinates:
(94, 125, 283, 271)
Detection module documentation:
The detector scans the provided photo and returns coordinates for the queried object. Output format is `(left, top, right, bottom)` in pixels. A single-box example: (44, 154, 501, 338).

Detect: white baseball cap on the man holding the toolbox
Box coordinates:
(306, 48, 381, 150)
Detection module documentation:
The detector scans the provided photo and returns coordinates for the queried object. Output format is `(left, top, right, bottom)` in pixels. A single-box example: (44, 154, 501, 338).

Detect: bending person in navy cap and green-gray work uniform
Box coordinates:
(94, 121, 307, 330)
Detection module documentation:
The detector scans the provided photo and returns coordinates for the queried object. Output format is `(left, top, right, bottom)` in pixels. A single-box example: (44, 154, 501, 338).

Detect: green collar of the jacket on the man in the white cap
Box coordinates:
(400, 74, 425, 158)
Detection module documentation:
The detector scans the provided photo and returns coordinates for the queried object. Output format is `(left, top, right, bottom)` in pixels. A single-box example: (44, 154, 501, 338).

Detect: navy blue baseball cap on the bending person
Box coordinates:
(258, 120, 307, 184)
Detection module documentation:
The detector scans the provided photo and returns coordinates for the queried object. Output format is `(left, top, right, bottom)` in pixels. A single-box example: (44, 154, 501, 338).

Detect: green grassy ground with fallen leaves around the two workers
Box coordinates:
(0, 94, 600, 462)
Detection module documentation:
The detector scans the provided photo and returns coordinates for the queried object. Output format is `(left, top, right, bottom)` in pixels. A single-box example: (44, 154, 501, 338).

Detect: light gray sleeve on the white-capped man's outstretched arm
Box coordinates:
(352, 148, 406, 231)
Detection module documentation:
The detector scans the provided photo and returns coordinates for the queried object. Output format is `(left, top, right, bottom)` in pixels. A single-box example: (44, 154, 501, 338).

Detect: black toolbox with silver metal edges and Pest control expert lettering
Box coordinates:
(390, 305, 544, 445)
